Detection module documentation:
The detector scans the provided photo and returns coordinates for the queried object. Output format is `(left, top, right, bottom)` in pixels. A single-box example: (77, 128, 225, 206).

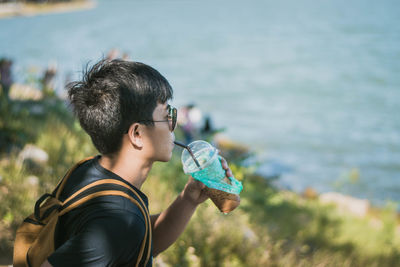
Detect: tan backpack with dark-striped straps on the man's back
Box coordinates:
(13, 158, 152, 267)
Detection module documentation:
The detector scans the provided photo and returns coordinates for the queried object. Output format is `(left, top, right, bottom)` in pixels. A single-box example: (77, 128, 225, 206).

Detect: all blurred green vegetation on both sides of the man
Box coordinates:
(0, 86, 400, 267)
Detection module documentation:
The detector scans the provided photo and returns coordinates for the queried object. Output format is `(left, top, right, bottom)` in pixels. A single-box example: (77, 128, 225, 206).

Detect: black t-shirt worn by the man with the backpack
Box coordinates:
(48, 156, 152, 267)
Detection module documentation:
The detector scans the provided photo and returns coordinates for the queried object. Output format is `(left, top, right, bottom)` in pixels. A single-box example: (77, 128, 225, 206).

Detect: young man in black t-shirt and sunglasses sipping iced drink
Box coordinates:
(42, 60, 232, 266)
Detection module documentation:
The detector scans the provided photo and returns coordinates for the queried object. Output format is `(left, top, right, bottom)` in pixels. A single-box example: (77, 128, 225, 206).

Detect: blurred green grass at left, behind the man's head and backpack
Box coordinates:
(0, 95, 95, 264)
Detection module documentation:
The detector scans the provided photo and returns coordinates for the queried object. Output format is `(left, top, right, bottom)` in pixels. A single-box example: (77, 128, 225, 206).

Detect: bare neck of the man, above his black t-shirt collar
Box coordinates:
(99, 152, 153, 189)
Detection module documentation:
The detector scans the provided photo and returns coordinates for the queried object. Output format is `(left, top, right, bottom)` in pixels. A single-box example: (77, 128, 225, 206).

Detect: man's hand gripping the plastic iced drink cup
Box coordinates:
(182, 157, 233, 206)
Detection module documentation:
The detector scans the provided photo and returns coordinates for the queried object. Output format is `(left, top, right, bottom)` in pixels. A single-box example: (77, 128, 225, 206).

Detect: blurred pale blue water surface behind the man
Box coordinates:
(0, 0, 400, 204)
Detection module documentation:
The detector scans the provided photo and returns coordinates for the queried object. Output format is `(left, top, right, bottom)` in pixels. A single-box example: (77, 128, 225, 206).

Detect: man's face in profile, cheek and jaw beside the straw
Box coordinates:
(144, 103, 175, 162)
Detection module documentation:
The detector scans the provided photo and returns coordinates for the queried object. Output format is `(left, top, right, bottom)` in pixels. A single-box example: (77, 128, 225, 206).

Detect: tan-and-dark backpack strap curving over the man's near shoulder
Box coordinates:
(59, 179, 152, 266)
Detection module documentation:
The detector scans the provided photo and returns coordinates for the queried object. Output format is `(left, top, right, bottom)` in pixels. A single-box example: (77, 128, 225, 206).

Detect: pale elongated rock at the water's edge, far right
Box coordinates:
(319, 192, 370, 217)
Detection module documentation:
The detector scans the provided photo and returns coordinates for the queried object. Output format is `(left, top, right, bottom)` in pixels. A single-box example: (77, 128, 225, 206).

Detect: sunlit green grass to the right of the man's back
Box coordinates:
(145, 162, 400, 266)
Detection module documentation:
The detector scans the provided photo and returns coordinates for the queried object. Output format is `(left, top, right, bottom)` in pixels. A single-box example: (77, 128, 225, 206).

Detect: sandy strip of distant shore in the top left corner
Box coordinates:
(0, 0, 96, 19)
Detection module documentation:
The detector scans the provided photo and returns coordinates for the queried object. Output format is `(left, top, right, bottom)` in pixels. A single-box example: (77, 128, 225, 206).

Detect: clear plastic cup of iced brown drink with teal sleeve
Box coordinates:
(181, 140, 243, 213)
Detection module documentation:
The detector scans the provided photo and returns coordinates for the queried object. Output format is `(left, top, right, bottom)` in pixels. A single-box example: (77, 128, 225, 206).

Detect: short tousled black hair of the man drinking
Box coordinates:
(68, 59, 173, 155)
